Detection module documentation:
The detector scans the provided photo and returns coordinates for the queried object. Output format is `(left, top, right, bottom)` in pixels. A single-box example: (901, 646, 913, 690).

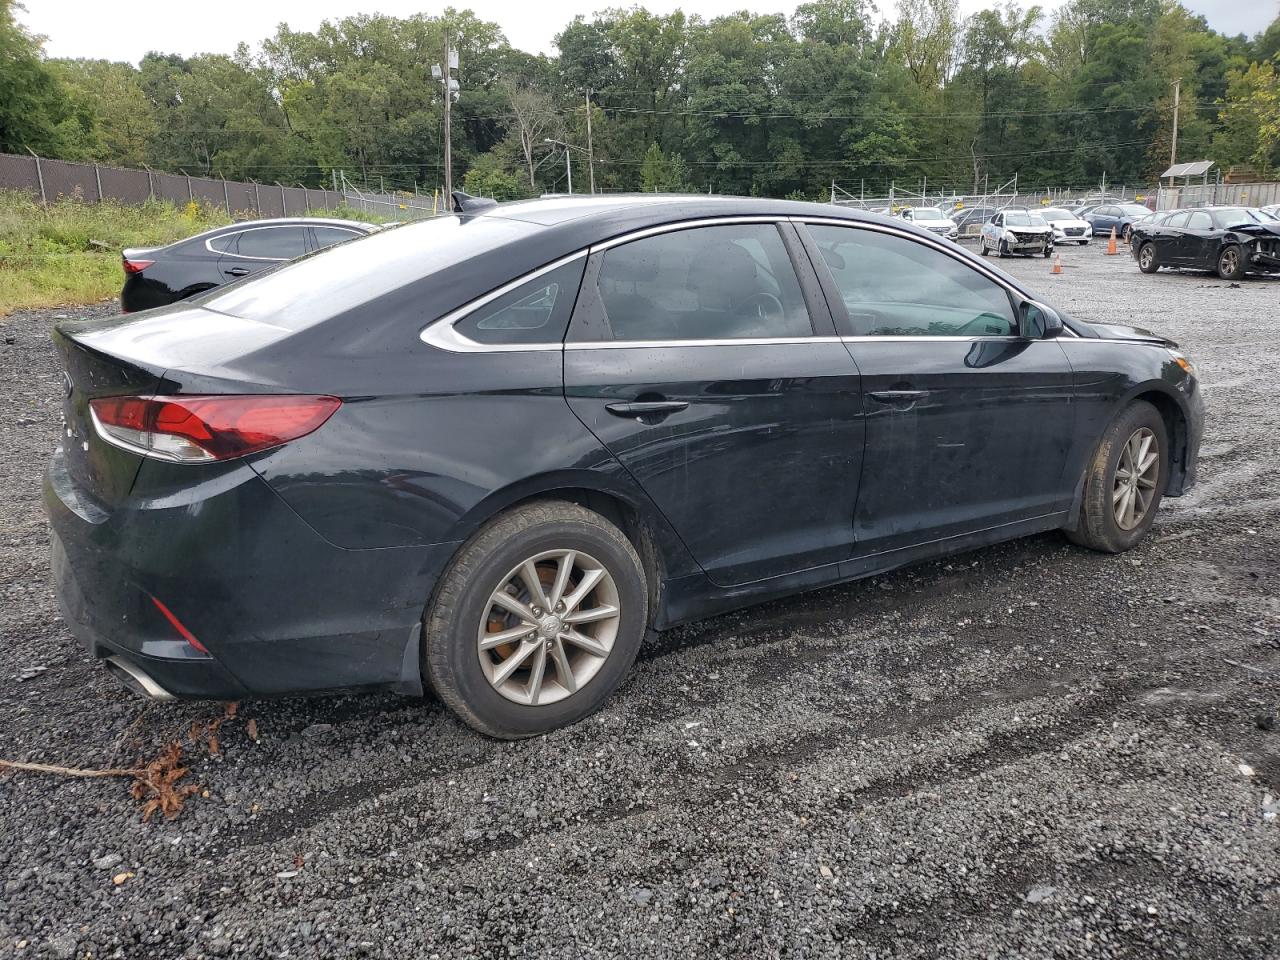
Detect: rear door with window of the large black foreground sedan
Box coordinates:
(564, 219, 863, 585)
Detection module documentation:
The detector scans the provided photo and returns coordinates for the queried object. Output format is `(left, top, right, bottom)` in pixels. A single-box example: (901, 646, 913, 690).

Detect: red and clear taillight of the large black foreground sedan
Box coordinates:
(90, 394, 342, 463)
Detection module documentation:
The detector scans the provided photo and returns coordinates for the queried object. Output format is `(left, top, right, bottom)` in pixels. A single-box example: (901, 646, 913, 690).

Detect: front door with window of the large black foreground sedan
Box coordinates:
(808, 221, 1074, 556)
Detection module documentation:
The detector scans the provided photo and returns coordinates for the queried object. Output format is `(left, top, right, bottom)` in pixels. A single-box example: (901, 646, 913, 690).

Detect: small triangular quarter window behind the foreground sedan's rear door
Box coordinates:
(453, 257, 586, 344)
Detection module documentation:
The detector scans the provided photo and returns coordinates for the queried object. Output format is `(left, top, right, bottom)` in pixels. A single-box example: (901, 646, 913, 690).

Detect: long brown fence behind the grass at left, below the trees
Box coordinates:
(0, 154, 436, 220)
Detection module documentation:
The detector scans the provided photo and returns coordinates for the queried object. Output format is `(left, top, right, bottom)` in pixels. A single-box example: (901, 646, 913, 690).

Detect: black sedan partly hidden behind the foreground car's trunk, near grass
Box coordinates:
(120, 216, 378, 312)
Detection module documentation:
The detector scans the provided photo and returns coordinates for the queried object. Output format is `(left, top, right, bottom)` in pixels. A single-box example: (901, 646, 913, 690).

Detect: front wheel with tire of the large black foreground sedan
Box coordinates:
(1066, 401, 1169, 553)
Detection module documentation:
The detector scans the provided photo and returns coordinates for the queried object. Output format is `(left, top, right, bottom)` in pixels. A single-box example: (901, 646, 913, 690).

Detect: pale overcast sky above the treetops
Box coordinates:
(18, 0, 1280, 63)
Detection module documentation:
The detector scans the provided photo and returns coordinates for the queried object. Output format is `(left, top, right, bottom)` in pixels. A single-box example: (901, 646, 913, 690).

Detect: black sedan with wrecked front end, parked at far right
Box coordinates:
(1129, 206, 1280, 280)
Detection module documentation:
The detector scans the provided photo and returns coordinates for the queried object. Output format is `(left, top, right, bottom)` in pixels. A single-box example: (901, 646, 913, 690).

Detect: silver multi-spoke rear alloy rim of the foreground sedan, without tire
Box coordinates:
(476, 549, 621, 707)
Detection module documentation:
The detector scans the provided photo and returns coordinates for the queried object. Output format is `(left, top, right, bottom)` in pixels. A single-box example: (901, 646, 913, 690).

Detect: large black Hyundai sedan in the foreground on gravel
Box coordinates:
(45, 195, 1203, 737)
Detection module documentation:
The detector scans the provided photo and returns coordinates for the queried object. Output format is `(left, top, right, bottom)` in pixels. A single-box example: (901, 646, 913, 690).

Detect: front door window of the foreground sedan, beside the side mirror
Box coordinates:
(809, 225, 1018, 337)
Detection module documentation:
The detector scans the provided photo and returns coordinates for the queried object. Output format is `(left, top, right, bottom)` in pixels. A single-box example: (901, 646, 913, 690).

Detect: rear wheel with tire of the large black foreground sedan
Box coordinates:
(422, 500, 649, 740)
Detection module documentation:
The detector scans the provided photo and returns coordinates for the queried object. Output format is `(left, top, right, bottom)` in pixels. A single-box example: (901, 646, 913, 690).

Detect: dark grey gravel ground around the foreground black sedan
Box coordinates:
(0, 244, 1280, 960)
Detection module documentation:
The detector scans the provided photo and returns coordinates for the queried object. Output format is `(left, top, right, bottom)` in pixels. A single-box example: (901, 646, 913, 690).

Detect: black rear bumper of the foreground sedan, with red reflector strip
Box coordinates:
(44, 451, 454, 699)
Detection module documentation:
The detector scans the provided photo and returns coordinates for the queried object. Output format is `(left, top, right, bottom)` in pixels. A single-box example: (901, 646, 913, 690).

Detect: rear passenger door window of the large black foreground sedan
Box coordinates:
(596, 224, 813, 340)
